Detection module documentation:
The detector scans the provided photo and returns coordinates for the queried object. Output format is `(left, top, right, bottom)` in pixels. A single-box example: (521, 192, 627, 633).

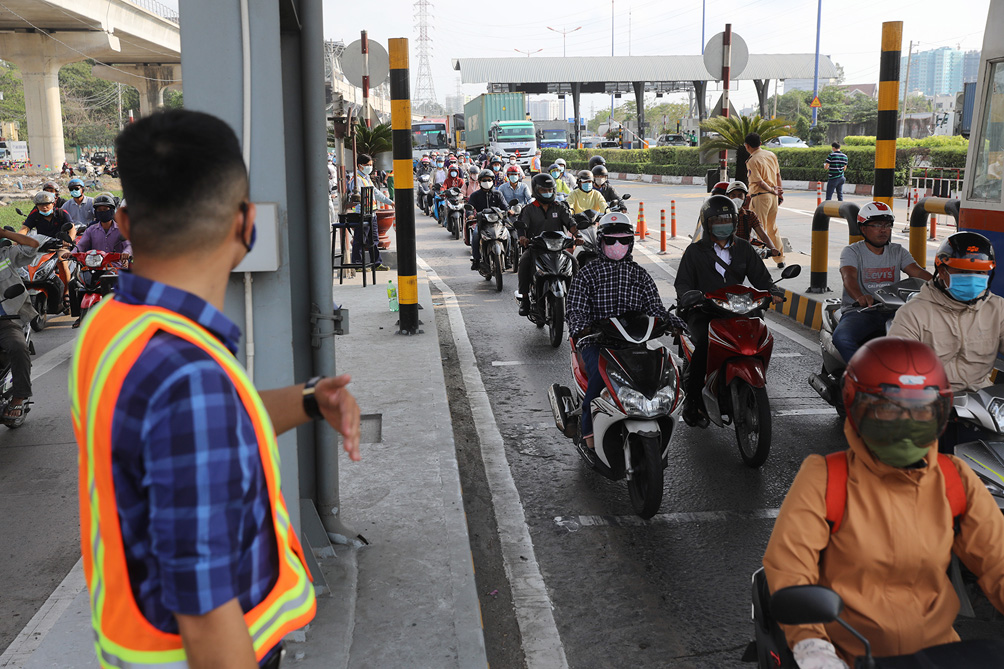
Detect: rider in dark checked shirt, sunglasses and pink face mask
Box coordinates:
(565, 213, 687, 451)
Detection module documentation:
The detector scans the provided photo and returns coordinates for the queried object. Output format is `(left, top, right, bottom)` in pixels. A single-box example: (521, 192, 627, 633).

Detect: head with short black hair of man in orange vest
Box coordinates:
(115, 109, 248, 256)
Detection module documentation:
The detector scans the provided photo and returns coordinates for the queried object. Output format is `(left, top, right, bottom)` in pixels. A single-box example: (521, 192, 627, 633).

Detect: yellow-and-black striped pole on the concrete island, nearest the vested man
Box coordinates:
(388, 37, 422, 335)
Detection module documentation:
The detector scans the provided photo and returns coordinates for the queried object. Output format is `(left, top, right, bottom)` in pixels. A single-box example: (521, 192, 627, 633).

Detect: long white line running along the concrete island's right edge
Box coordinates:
(418, 257, 568, 669)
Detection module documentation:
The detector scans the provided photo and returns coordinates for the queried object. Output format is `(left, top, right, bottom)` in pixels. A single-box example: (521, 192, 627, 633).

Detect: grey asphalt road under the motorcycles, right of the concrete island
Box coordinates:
(417, 178, 1001, 667)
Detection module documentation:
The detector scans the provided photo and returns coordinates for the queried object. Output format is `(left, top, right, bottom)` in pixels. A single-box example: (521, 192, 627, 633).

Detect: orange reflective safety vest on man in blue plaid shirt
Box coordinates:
(69, 299, 316, 668)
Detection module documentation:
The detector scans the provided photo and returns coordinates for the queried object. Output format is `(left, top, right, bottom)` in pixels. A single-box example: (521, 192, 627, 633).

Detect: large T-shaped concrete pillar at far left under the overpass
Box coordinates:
(0, 32, 119, 169)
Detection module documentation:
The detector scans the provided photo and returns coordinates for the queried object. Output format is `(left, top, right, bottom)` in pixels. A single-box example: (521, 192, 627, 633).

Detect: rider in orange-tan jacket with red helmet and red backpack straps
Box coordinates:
(763, 337, 1004, 669)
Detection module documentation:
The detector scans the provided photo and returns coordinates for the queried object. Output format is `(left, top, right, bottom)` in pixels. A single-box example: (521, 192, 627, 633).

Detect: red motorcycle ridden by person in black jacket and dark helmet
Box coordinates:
(679, 265, 801, 467)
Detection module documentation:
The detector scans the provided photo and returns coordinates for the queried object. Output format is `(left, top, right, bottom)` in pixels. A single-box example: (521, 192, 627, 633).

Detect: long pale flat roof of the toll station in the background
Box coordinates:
(453, 53, 837, 84)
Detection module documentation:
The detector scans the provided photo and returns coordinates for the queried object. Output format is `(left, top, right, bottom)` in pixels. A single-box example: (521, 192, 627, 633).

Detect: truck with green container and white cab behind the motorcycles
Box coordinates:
(464, 93, 537, 169)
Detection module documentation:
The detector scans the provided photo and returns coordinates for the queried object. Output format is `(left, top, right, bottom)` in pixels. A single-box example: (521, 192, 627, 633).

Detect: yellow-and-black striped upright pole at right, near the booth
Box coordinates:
(872, 21, 903, 209)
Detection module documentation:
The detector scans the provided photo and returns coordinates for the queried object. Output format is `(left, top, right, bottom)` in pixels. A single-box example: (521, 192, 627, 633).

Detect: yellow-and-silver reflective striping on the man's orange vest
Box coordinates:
(76, 300, 313, 668)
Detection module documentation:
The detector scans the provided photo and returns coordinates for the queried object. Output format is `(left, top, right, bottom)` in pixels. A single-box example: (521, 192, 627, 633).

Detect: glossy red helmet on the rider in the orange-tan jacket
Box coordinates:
(843, 337, 952, 434)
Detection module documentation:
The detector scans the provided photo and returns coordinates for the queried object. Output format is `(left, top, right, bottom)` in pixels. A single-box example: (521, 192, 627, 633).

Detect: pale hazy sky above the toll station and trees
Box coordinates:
(162, 0, 990, 115)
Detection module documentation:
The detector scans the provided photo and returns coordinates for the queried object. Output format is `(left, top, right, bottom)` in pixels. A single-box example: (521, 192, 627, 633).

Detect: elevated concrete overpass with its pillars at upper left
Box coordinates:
(0, 0, 182, 168)
